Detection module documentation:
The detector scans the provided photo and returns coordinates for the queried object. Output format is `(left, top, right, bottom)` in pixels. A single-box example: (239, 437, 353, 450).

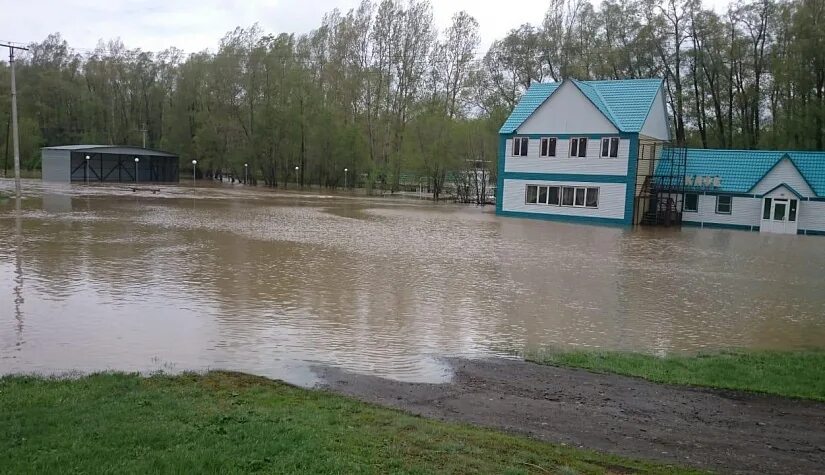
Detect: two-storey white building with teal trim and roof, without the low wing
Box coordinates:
(496, 79, 670, 224)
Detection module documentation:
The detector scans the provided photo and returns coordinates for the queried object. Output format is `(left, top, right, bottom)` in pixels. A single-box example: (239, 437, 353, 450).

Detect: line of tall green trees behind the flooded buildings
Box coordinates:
(0, 0, 825, 195)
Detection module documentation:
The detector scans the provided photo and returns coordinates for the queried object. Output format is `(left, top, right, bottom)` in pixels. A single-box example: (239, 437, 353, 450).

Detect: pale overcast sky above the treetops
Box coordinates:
(0, 0, 728, 53)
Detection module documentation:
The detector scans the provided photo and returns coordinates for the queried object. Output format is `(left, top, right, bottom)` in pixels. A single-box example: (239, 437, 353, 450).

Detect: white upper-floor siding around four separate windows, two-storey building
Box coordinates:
(504, 134, 630, 175)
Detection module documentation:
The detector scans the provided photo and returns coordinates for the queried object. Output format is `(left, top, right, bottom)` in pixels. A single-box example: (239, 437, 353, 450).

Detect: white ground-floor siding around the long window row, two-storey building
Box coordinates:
(502, 179, 625, 219)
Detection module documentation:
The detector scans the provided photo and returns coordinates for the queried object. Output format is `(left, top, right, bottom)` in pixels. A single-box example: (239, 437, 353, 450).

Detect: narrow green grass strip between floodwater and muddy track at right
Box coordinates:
(525, 351, 825, 401)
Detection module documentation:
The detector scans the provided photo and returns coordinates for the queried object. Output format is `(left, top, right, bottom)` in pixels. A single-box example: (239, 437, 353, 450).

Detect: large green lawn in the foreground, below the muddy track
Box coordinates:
(0, 372, 687, 474)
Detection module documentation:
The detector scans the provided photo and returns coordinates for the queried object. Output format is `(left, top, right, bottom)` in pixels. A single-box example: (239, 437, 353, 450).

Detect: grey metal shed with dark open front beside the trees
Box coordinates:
(42, 145, 180, 183)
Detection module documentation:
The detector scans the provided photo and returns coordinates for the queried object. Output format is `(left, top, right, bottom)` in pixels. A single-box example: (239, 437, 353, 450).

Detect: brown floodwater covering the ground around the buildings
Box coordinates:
(0, 181, 825, 384)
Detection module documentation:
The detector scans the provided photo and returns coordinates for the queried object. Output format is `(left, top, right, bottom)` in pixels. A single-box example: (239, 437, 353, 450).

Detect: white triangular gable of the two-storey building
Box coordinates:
(517, 81, 619, 134)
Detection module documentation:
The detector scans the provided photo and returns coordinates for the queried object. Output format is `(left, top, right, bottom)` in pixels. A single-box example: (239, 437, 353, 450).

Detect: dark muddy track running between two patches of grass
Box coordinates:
(320, 359, 825, 473)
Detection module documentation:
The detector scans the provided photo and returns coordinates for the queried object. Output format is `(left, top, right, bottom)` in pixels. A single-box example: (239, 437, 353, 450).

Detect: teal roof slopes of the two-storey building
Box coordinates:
(499, 79, 662, 134)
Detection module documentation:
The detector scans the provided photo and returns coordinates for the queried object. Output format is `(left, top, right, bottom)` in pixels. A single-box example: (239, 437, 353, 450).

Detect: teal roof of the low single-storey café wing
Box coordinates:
(655, 149, 825, 196)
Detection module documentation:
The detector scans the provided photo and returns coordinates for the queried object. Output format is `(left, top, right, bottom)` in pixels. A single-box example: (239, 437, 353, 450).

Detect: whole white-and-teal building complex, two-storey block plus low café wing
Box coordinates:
(496, 79, 825, 234)
